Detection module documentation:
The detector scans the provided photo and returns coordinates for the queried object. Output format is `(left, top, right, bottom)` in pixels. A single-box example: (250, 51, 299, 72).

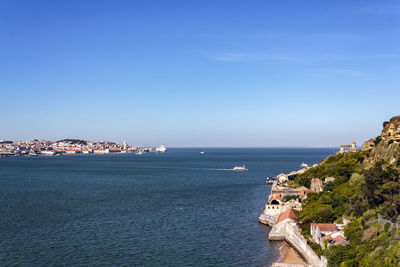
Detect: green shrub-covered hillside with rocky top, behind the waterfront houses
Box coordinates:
(295, 116, 400, 266)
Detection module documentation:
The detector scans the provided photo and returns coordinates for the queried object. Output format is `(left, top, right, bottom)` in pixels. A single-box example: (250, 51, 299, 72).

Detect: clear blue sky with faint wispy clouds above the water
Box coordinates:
(0, 0, 400, 147)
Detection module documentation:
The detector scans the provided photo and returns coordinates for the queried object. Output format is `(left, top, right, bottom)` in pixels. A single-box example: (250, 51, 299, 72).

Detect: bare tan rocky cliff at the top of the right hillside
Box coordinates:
(363, 116, 400, 169)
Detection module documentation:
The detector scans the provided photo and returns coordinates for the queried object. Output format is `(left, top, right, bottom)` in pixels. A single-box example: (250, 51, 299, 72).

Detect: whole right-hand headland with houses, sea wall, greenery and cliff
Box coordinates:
(259, 116, 400, 266)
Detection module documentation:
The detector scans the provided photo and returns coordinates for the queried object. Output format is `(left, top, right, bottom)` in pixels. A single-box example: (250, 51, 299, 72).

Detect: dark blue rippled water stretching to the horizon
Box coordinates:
(0, 148, 336, 266)
